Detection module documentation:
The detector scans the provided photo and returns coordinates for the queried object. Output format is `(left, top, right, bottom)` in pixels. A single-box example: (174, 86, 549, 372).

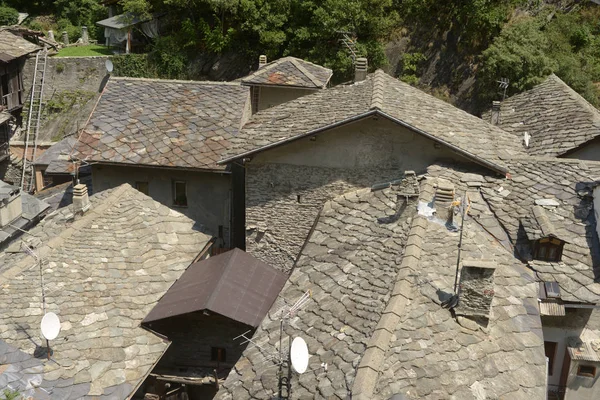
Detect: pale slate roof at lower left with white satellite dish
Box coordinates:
(0, 185, 209, 400)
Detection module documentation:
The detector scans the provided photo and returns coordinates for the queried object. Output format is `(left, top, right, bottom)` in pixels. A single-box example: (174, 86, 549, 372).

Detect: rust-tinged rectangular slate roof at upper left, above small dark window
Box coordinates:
(74, 78, 251, 170)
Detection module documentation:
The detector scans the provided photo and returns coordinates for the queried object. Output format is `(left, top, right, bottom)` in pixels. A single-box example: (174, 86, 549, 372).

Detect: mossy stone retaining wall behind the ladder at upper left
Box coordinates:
(15, 57, 108, 142)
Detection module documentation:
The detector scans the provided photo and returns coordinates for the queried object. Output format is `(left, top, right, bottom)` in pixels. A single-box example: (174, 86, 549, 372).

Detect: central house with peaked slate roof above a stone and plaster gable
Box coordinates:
(221, 70, 524, 271)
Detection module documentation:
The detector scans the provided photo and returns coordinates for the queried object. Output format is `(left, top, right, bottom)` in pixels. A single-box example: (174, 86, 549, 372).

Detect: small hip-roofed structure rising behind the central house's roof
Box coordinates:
(242, 55, 333, 113)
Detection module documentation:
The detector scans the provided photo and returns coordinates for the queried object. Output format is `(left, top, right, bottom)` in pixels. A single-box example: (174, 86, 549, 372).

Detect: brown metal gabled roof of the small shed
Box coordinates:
(143, 249, 287, 327)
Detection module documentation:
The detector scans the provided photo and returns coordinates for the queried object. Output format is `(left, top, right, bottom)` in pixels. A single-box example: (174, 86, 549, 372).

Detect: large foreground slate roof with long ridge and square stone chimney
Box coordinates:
(216, 173, 546, 400)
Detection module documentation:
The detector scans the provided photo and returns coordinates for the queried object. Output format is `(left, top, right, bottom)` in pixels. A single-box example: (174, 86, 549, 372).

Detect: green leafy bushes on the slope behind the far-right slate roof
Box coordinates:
(478, 10, 600, 105)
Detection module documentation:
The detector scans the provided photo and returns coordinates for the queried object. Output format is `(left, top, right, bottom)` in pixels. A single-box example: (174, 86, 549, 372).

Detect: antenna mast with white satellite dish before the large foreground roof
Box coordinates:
(233, 290, 318, 400)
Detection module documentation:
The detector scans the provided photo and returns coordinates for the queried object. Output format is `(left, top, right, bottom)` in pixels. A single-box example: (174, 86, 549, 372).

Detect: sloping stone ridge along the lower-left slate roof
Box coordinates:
(0, 183, 133, 282)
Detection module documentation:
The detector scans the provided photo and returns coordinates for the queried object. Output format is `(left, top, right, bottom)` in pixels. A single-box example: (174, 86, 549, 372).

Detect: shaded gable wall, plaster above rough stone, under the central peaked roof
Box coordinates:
(246, 118, 478, 271)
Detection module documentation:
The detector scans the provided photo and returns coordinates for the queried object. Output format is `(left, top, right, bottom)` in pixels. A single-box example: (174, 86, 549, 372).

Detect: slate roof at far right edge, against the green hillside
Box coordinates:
(483, 74, 600, 156)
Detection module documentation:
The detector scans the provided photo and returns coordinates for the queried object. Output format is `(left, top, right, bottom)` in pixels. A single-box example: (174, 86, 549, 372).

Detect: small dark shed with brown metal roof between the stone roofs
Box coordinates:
(141, 249, 287, 400)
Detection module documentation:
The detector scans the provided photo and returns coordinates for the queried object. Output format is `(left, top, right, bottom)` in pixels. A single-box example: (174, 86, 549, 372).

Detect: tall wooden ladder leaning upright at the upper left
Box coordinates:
(21, 47, 48, 193)
